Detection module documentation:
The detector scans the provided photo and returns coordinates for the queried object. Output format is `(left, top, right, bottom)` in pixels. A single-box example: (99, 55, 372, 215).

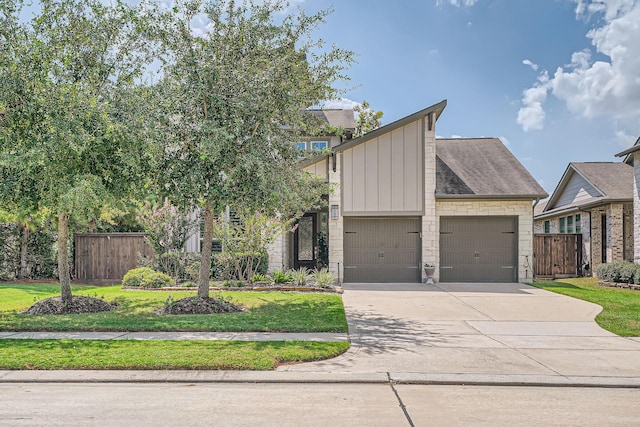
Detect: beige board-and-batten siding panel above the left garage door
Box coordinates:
(342, 120, 424, 216)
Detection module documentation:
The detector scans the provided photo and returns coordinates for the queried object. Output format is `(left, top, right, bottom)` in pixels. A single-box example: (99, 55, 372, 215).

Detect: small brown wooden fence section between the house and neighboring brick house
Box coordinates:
(533, 234, 582, 279)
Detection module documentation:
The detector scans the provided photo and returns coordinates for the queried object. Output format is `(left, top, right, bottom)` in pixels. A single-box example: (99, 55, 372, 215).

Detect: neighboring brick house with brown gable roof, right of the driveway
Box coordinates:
(534, 162, 634, 272)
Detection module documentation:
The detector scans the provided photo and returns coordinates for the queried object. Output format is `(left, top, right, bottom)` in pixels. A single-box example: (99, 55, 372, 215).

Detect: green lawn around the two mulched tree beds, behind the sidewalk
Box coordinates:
(0, 284, 347, 332)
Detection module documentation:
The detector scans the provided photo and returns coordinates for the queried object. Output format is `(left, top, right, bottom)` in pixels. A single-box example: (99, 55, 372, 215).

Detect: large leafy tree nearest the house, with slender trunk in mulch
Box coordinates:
(154, 0, 352, 297)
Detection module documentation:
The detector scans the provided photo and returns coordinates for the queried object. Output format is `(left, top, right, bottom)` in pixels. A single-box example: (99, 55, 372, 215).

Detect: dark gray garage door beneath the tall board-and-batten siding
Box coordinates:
(344, 218, 421, 283)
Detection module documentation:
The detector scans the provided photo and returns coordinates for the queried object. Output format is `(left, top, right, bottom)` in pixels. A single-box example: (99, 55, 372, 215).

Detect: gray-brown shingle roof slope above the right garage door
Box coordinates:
(436, 138, 547, 198)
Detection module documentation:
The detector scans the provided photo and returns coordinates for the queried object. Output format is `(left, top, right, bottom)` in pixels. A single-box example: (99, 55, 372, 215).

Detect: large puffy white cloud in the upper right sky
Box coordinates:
(518, 0, 640, 131)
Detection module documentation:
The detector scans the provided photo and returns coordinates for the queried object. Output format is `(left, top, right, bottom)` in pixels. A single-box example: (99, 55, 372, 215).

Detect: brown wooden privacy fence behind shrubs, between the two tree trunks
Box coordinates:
(73, 233, 153, 283)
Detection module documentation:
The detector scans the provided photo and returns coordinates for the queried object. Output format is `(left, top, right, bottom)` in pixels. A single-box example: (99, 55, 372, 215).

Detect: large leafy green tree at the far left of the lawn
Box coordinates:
(0, 0, 150, 303)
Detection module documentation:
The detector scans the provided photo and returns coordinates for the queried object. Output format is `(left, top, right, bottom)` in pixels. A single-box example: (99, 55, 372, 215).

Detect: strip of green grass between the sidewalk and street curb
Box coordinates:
(0, 339, 349, 370)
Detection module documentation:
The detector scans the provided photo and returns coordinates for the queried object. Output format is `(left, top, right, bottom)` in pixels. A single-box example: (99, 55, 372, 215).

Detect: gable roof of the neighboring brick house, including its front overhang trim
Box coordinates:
(538, 162, 633, 216)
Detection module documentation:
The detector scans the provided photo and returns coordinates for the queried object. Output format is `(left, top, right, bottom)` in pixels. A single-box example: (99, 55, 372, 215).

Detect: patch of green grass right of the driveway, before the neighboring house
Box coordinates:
(533, 277, 640, 337)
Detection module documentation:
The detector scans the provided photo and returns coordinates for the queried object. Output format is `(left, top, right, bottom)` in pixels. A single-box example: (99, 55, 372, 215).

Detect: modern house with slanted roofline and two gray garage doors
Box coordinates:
(269, 101, 547, 283)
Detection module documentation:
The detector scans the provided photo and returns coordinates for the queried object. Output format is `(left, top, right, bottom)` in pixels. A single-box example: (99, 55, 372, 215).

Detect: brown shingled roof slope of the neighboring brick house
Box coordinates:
(571, 162, 633, 199)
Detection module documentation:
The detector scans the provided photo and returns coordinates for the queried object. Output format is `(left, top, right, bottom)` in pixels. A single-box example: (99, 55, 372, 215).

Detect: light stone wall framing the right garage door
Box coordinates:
(435, 200, 534, 282)
